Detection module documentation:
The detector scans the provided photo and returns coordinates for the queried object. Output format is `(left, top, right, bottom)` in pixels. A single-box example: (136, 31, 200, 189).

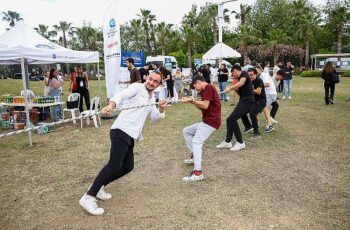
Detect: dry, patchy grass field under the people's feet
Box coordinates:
(0, 77, 350, 229)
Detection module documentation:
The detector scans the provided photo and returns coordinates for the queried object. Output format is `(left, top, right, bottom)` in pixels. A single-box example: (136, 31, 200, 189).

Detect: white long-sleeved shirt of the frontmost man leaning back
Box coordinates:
(110, 83, 165, 141)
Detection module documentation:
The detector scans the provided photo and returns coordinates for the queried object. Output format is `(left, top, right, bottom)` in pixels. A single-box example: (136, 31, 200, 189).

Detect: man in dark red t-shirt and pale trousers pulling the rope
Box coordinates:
(182, 75, 221, 182)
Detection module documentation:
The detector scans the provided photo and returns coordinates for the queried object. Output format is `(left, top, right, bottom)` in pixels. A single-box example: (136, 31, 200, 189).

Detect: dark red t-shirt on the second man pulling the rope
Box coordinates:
(200, 84, 221, 129)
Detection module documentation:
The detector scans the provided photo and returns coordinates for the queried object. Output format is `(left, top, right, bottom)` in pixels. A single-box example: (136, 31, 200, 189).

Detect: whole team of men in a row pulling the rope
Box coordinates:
(79, 56, 292, 215)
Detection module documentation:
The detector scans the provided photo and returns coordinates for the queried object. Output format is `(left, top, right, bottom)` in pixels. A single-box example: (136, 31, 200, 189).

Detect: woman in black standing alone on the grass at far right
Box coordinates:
(322, 61, 337, 105)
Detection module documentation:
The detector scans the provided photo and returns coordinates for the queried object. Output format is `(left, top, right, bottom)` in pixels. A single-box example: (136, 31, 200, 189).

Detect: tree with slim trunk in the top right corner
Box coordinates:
(325, 0, 350, 53)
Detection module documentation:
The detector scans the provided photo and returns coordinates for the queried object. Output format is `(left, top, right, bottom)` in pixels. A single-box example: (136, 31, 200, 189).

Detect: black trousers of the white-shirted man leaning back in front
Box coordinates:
(87, 129, 134, 197)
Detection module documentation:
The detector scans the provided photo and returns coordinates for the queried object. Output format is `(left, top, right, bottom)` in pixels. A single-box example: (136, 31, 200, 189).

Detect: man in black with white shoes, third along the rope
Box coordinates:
(216, 65, 258, 151)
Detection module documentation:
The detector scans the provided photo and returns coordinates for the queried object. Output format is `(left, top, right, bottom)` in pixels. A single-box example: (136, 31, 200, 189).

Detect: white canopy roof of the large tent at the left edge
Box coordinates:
(0, 23, 99, 65)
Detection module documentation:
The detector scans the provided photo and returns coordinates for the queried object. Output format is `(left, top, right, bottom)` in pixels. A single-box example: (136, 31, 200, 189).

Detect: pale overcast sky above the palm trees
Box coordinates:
(0, 0, 326, 34)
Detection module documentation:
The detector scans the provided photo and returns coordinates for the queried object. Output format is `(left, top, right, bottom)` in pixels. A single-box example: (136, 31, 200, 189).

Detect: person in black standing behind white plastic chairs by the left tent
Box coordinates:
(75, 67, 90, 112)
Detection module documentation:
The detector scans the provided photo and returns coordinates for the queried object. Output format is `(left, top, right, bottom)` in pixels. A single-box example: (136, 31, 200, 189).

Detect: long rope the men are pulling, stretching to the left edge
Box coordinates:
(0, 97, 200, 139)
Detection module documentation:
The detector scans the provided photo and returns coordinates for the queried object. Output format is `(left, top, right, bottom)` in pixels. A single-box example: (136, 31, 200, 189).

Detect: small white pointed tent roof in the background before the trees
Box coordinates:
(203, 42, 241, 59)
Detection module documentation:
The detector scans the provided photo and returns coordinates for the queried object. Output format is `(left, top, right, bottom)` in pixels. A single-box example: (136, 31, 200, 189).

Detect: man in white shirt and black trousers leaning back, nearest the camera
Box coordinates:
(79, 72, 167, 215)
